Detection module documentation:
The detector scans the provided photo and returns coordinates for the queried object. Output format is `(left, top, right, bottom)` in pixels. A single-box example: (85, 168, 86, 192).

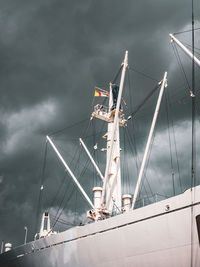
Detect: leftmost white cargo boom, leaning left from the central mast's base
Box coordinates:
(46, 135, 94, 209)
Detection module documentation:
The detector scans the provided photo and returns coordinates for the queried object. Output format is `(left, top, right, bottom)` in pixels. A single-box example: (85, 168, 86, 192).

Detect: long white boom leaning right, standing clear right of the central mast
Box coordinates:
(131, 72, 167, 209)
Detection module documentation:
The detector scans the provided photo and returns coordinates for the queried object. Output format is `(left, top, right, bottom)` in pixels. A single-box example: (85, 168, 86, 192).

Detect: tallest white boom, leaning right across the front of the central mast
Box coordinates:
(101, 51, 128, 204)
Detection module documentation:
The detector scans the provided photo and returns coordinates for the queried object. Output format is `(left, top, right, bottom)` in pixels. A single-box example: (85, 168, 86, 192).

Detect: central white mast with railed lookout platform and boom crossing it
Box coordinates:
(92, 51, 128, 216)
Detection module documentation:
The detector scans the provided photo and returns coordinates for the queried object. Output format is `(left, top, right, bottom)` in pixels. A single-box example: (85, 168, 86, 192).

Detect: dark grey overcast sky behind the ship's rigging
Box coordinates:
(0, 0, 200, 249)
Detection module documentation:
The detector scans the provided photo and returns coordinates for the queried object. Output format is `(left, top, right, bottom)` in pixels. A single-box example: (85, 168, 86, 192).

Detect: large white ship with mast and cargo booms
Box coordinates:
(0, 31, 200, 267)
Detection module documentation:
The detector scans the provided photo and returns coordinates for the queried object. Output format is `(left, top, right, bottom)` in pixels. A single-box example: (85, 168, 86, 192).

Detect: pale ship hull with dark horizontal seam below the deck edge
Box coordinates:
(0, 186, 200, 267)
